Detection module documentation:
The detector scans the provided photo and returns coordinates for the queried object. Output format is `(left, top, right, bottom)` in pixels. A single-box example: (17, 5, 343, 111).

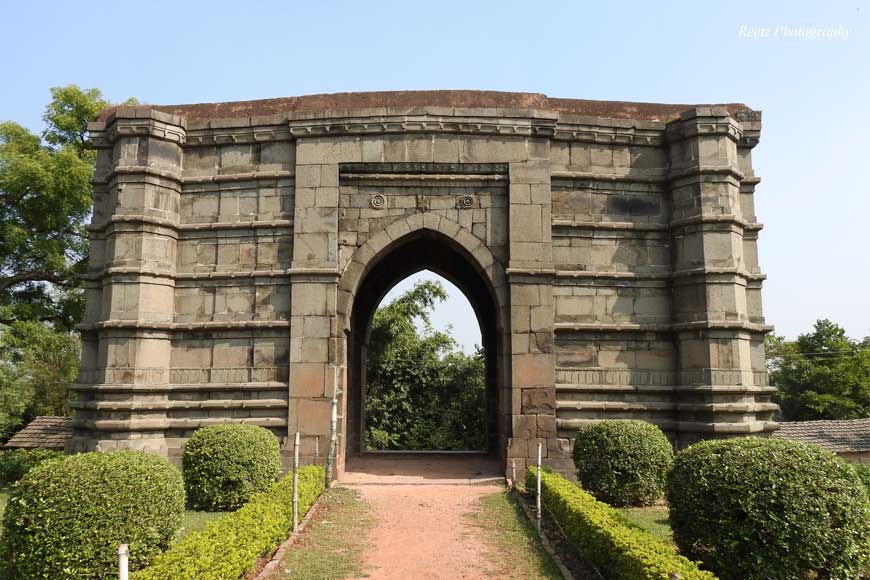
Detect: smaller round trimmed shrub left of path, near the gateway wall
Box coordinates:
(183, 423, 281, 511)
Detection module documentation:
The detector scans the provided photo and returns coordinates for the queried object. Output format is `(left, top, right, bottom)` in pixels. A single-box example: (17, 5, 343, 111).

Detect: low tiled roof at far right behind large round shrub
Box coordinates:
(774, 419, 870, 464)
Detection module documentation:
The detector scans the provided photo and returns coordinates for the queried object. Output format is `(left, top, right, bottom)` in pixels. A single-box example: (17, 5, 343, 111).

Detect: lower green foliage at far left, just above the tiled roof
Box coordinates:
(0, 321, 81, 441)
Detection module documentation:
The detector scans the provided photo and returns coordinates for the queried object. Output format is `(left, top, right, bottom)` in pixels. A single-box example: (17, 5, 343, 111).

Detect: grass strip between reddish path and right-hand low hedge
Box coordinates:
(469, 492, 562, 580)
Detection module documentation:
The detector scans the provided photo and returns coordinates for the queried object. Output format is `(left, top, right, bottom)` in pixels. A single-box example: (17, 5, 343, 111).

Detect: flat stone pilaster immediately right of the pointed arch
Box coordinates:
(508, 159, 570, 470)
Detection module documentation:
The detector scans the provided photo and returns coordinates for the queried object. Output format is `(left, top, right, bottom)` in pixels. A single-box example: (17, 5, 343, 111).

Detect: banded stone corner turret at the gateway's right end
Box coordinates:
(666, 107, 776, 445)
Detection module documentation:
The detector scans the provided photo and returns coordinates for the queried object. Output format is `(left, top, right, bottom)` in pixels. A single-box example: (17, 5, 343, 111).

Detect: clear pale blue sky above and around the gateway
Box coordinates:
(0, 0, 870, 348)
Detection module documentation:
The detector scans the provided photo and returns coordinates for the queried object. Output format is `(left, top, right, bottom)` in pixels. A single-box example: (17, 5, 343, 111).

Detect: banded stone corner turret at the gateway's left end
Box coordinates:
(71, 107, 185, 454)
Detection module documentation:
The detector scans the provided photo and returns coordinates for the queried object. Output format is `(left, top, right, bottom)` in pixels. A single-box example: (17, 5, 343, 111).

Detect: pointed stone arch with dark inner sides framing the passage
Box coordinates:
(336, 213, 513, 458)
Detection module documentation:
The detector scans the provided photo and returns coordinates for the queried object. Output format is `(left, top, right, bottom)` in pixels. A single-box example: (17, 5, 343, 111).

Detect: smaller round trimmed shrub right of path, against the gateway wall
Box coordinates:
(574, 421, 674, 506)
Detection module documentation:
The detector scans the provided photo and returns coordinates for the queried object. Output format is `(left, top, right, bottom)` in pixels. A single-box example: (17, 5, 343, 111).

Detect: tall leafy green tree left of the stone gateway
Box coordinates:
(0, 85, 135, 441)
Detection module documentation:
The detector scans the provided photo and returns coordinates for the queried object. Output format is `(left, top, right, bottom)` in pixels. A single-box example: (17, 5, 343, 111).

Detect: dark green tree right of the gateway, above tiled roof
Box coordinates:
(765, 320, 870, 421)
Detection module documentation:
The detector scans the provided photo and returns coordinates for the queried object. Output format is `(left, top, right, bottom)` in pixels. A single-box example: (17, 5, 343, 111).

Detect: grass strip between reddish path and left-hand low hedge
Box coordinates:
(276, 487, 374, 580)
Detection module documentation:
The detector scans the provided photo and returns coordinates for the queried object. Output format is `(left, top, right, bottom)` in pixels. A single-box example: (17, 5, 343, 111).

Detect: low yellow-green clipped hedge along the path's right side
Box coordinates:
(526, 468, 716, 580)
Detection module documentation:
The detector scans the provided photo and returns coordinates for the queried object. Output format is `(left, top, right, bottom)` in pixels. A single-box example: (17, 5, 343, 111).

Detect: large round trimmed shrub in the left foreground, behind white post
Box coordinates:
(0, 451, 184, 580)
